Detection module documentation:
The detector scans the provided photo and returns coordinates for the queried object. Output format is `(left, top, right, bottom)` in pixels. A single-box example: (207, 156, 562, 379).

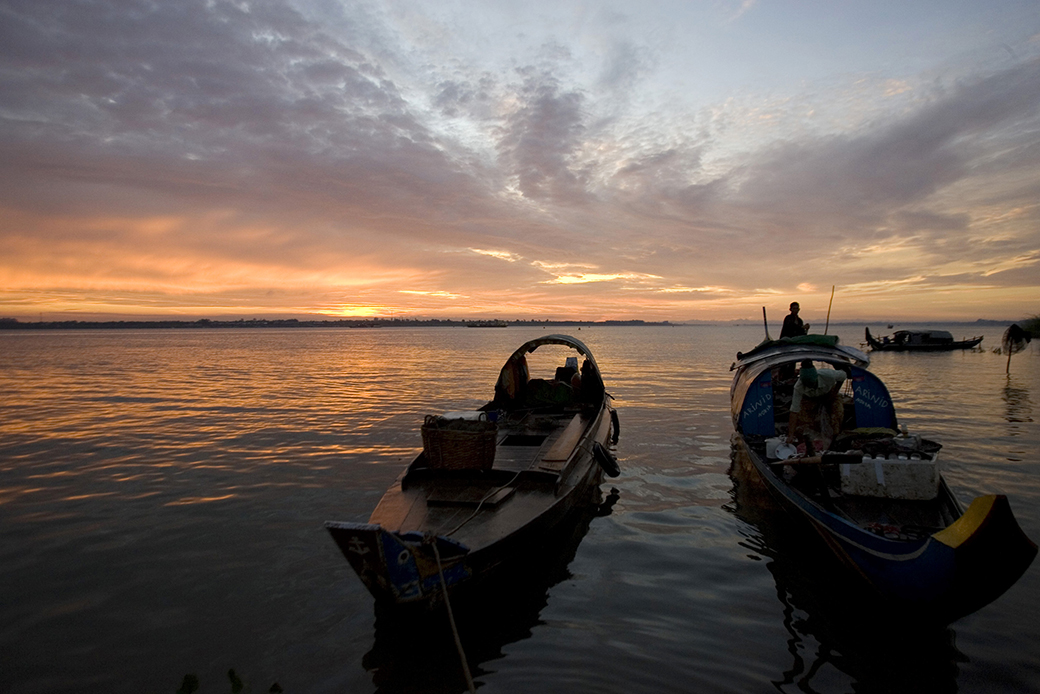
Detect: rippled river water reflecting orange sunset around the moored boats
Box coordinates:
(0, 326, 1040, 694)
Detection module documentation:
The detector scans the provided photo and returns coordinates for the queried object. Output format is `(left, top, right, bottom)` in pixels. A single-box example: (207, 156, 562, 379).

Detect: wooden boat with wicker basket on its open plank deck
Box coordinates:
(326, 335, 620, 607)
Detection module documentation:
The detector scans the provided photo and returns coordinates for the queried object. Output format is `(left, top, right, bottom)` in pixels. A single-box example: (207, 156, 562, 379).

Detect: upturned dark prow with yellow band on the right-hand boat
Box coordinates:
(932, 494, 1037, 616)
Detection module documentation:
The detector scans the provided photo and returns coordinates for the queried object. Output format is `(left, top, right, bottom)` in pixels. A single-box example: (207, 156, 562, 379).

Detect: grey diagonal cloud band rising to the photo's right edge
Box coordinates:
(737, 61, 1040, 224)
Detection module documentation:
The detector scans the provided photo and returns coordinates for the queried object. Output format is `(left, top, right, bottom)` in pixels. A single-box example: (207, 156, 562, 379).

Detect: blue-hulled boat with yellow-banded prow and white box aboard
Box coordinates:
(730, 335, 1037, 622)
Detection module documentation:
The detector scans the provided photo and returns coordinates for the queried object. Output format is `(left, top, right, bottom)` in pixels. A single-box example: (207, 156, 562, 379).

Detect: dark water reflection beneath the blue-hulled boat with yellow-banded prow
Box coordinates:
(726, 452, 967, 694)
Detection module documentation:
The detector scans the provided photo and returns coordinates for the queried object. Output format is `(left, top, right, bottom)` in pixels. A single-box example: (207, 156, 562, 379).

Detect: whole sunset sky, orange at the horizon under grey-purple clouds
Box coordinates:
(0, 0, 1040, 320)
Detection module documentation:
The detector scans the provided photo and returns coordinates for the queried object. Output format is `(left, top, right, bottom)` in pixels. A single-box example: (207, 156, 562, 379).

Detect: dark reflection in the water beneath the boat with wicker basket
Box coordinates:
(362, 487, 619, 694)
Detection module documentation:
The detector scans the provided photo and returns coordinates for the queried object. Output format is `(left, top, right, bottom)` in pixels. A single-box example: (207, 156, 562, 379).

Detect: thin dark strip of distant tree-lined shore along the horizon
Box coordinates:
(0, 318, 676, 330)
